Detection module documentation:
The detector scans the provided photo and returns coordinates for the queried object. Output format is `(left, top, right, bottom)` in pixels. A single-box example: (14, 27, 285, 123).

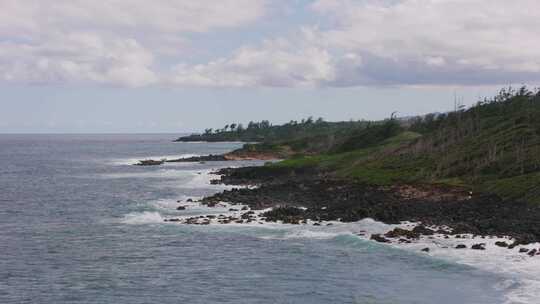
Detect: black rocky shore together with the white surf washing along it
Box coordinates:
(150, 150, 540, 303)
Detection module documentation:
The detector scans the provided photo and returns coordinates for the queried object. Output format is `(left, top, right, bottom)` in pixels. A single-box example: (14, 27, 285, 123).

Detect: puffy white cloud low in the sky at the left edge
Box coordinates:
(0, 32, 158, 86)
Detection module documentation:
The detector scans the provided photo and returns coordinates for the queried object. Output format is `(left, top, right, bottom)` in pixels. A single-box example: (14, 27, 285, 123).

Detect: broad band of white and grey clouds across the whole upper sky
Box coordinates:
(0, 0, 540, 87)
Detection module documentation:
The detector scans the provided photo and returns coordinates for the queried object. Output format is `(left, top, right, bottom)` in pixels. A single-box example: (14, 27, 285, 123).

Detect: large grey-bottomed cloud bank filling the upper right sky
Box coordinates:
(312, 0, 540, 84)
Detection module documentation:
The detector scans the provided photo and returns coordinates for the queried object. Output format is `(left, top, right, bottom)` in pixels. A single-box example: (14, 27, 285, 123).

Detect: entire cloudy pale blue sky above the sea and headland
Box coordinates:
(0, 0, 540, 133)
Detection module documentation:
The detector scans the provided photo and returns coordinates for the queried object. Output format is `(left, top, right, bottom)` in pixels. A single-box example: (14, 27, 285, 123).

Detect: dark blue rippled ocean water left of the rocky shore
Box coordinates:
(0, 135, 502, 304)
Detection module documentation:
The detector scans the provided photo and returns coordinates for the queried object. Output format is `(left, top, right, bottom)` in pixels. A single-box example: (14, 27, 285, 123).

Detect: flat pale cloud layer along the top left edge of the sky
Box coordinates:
(0, 0, 265, 33)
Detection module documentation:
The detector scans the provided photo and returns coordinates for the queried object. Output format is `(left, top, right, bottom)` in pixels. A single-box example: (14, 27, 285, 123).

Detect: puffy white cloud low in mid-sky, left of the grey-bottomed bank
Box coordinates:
(171, 40, 335, 87)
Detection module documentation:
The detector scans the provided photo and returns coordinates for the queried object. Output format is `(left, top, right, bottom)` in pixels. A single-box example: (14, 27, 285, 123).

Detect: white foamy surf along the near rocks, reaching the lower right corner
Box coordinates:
(168, 212, 540, 304)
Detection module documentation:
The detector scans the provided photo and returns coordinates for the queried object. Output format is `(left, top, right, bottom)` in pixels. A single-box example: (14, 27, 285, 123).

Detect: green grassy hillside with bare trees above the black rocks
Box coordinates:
(264, 92, 540, 203)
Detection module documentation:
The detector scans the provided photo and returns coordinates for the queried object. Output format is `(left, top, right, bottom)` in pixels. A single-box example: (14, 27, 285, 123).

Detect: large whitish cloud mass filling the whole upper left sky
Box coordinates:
(0, 0, 266, 86)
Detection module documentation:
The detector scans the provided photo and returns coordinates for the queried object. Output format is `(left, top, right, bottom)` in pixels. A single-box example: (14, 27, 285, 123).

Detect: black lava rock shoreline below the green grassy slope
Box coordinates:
(198, 167, 540, 256)
